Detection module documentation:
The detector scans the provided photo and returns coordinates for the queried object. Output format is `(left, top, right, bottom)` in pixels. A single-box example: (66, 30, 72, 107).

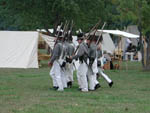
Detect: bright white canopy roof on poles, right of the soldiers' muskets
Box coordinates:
(98, 30, 139, 38)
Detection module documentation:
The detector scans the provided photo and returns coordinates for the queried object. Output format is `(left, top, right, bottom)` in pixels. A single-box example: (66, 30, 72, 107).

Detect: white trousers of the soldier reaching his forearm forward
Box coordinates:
(77, 62, 88, 91)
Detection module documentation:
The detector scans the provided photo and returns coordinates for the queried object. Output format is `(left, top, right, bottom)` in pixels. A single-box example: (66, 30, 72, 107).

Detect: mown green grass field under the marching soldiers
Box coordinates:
(0, 62, 150, 113)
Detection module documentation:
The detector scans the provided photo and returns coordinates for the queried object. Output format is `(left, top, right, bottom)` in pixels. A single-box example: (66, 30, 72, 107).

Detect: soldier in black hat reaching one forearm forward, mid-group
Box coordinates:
(67, 33, 88, 92)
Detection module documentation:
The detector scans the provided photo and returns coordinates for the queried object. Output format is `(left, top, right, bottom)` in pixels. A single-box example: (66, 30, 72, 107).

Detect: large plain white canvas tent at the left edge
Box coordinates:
(0, 31, 39, 68)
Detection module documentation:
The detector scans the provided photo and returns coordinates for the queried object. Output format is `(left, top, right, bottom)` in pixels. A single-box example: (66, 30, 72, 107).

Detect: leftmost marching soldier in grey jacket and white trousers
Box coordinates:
(48, 33, 64, 91)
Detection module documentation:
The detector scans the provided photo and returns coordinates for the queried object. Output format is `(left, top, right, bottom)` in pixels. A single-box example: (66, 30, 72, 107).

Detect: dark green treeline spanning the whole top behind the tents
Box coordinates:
(0, 0, 150, 33)
